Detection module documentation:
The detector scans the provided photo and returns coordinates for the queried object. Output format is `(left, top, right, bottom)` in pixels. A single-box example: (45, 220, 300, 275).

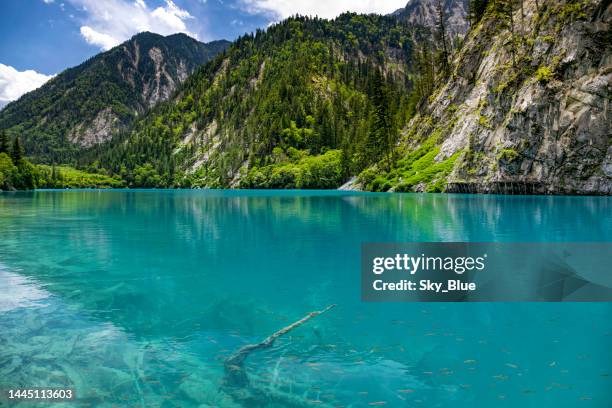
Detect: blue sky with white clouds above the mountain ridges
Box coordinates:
(0, 0, 408, 108)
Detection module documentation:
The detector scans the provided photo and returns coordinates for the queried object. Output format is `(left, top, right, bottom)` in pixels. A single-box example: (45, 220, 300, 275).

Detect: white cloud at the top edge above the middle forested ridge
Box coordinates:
(240, 0, 408, 18)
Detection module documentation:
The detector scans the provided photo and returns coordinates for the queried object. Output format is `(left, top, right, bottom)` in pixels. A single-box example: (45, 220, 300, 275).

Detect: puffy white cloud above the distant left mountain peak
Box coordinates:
(70, 0, 197, 50)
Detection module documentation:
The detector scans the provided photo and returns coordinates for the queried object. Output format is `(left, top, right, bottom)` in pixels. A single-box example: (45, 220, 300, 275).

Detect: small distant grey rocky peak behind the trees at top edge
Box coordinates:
(393, 0, 469, 39)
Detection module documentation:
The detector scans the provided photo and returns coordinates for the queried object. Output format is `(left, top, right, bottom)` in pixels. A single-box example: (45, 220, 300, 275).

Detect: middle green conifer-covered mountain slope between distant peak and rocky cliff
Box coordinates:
(84, 14, 411, 188)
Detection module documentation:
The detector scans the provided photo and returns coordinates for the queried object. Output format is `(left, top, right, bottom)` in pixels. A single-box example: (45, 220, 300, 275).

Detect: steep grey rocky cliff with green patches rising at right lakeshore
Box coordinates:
(360, 0, 612, 194)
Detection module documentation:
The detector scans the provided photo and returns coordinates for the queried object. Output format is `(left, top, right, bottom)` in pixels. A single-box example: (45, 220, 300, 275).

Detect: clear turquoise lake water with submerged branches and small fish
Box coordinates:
(0, 190, 612, 408)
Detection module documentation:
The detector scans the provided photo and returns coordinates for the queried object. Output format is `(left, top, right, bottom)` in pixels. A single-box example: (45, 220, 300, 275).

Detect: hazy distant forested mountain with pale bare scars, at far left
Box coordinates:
(0, 32, 229, 163)
